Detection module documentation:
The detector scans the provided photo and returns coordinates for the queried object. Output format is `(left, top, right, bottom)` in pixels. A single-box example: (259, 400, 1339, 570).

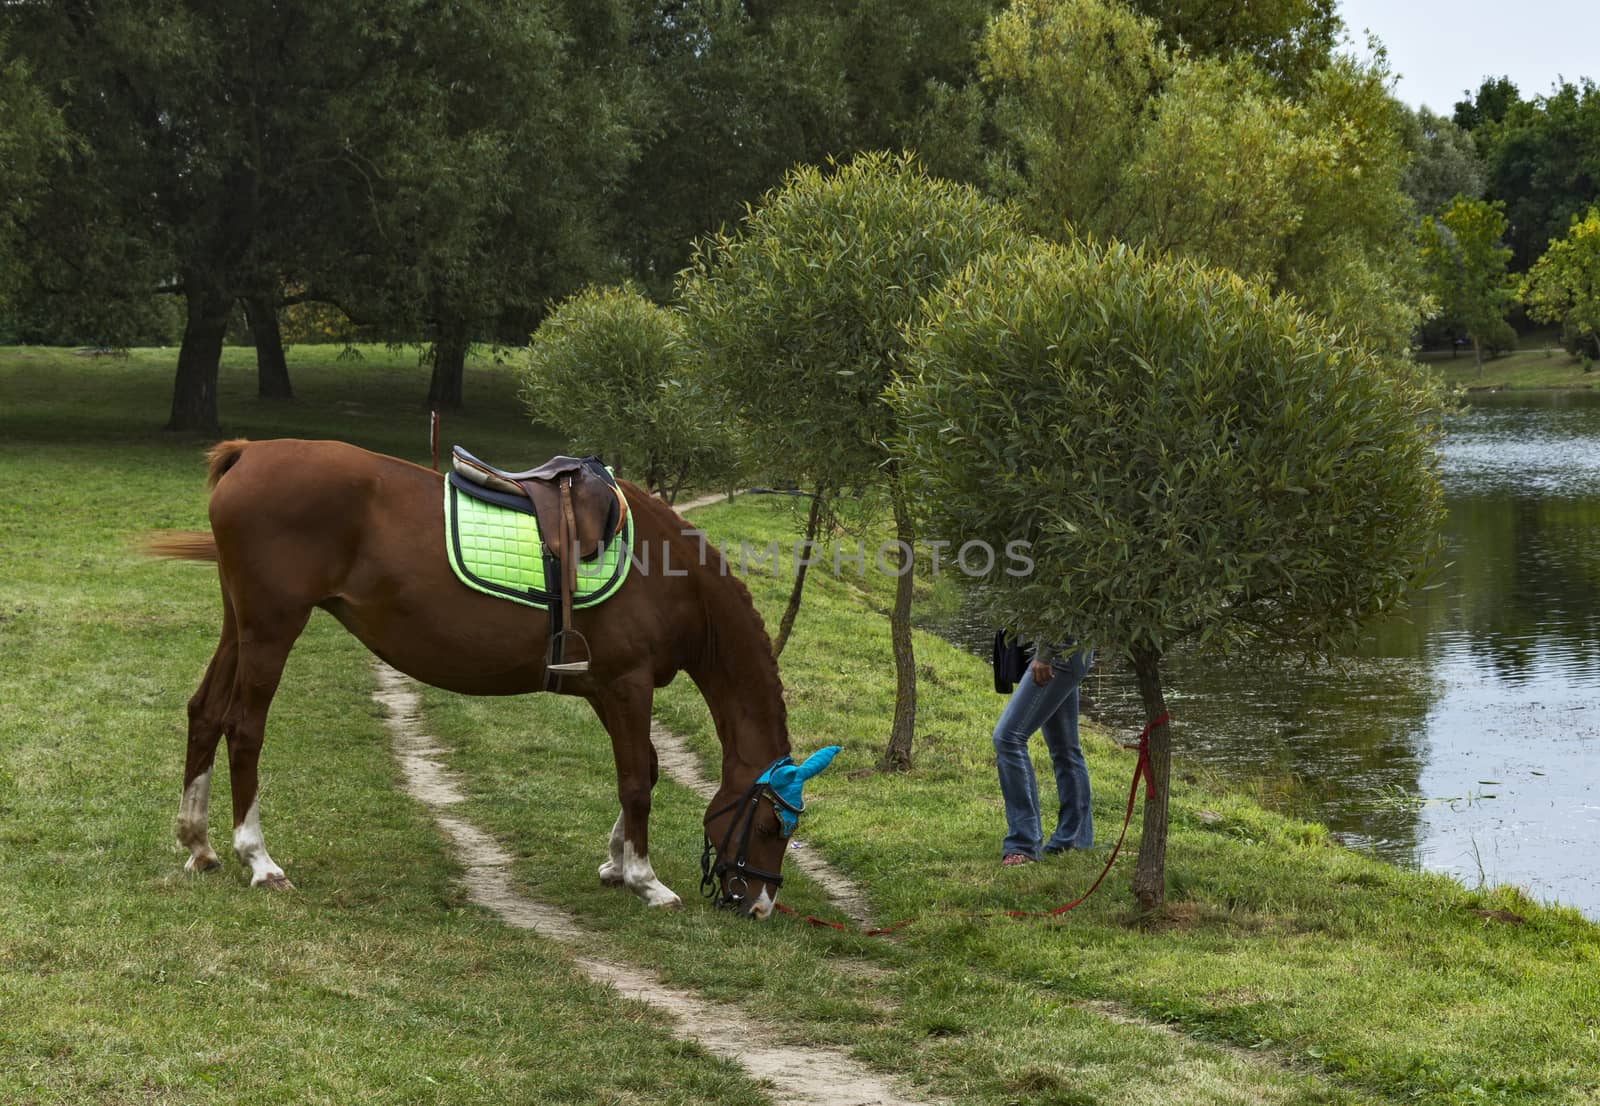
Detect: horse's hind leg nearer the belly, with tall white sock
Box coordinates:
(226, 607, 310, 888)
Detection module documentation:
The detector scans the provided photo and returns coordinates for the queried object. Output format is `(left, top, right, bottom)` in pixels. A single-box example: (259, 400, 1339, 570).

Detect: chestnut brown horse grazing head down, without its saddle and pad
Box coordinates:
(150, 439, 825, 919)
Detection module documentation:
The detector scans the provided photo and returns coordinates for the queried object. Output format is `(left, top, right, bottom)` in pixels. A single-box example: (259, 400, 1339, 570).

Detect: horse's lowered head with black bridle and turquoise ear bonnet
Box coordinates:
(701, 744, 840, 920)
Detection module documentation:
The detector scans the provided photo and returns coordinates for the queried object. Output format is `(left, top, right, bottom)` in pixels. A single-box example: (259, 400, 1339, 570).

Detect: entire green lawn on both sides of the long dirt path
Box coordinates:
(0, 351, 1600, 1106)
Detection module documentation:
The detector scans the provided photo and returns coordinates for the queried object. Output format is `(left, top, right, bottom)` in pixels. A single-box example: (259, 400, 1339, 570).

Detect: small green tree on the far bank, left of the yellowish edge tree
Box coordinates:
(1416, 195, 1515, 371)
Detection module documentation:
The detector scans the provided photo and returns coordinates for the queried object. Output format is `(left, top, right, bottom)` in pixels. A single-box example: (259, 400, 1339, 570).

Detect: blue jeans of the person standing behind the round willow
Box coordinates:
(994, 650, 1094, 860)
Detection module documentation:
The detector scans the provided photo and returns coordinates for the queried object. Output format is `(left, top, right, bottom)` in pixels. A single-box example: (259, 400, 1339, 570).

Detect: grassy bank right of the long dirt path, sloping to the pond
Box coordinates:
(429, 499, 1600, 1103)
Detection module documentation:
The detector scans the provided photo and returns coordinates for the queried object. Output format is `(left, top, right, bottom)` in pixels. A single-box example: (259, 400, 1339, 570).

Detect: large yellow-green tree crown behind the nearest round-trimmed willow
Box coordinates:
(982, 0, 1422, 354)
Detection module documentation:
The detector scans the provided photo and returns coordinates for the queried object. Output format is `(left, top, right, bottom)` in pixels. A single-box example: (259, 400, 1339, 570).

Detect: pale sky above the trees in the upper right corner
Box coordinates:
(1339, 0, 1600, 115)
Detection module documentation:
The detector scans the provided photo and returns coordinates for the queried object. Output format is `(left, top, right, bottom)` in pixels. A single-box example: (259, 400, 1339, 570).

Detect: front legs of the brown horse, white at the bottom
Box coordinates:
(589, 679, 683, 906)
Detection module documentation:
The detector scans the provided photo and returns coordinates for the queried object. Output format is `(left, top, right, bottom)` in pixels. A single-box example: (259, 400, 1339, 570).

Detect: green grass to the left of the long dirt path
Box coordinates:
(0, 351, 760, 1106)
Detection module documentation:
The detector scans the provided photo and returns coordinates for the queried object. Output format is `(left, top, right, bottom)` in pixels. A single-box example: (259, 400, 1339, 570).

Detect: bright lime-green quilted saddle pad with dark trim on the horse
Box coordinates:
(445, 479, 634, 610)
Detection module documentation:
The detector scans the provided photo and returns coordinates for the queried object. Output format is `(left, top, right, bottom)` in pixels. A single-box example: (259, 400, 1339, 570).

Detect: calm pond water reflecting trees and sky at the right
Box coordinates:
(931, 392, 1600, 919)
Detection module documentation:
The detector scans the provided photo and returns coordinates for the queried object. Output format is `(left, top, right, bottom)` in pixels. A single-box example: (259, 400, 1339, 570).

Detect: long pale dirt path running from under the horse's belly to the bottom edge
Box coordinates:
(373, 663, 938, 1106)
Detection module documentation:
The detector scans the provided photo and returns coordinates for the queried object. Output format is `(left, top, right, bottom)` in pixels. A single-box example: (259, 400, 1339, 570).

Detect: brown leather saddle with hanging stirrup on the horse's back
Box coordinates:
(451, 445, 627, 678)
